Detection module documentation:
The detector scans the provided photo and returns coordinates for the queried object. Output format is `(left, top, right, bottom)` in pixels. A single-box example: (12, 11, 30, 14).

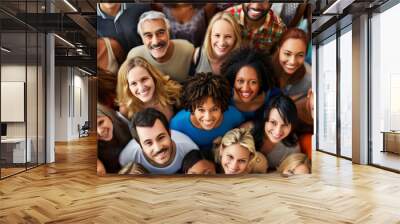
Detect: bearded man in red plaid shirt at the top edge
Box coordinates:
(226, 1, 286, 53)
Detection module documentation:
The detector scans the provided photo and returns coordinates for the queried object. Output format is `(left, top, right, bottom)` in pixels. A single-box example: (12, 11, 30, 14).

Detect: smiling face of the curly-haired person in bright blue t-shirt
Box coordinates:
(192, 97, 223, 130)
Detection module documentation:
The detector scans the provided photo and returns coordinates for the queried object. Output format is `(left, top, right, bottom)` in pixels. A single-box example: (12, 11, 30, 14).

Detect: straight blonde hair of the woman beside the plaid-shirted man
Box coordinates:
(204, 12, 242, 58)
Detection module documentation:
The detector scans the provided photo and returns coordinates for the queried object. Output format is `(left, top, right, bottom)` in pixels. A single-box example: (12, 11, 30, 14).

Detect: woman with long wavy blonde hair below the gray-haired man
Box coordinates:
(117, 57, 182, 120)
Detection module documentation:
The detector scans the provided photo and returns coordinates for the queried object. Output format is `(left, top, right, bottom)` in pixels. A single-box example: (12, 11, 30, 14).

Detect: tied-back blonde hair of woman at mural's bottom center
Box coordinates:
(214, 128, 256, 164)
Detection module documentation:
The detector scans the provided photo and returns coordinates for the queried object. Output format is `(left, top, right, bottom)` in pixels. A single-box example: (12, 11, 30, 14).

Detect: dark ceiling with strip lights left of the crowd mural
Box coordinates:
(0, 0, 96, 74)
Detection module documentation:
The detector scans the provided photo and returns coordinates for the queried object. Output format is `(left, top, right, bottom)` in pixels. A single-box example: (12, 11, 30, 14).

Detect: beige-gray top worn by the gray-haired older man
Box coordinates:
(126, 39, 194, 83)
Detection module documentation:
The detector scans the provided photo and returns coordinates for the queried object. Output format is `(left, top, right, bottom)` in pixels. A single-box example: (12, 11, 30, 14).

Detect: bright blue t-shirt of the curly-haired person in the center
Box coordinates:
(170, 106, 244, 150)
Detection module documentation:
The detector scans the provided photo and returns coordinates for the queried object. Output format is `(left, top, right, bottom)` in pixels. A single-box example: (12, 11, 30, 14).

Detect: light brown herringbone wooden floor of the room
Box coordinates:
(0, 138, 400, 224)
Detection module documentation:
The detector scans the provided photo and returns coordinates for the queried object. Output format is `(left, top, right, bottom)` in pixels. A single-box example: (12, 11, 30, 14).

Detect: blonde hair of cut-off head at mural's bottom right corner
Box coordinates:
(277, 153, 311, 177)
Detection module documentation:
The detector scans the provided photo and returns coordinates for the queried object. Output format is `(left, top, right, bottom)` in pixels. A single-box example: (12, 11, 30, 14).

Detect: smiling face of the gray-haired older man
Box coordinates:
(141, 19, 170, 62)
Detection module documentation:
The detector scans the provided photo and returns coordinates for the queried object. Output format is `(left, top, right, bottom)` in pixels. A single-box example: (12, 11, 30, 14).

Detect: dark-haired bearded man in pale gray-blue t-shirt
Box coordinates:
(119, 108, 198, 174)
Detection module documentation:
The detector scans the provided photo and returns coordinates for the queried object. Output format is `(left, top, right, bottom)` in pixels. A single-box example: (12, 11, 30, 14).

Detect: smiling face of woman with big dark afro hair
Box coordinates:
(234, 66, 260, 103)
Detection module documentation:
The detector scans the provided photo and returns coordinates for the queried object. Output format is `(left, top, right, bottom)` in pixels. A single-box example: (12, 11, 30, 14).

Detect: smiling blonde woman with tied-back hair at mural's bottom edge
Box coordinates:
(214, 128, 268, 174)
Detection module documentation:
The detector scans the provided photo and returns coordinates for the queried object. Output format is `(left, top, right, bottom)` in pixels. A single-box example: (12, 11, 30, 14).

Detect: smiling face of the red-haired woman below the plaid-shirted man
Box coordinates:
(279, 38, 307, 75)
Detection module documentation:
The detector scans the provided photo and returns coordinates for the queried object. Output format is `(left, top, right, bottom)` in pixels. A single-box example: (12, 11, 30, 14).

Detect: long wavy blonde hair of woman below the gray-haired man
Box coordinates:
(117, 57, 182, 118)
